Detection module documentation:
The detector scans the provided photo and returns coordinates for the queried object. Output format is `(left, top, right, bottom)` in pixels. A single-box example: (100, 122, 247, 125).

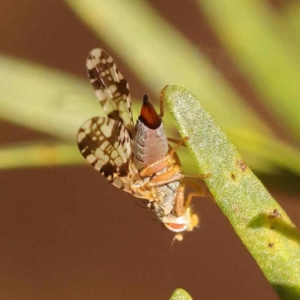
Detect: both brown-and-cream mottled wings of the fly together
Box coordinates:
(77, 49, 135, 192)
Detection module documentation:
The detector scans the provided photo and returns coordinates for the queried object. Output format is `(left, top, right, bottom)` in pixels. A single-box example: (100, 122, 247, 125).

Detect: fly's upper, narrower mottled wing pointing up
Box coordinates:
(86, 49, 134, 138)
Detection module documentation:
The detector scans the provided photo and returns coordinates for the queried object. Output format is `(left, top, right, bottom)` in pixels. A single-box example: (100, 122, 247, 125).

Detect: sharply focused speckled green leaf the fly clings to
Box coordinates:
(163, 86, 300, 299)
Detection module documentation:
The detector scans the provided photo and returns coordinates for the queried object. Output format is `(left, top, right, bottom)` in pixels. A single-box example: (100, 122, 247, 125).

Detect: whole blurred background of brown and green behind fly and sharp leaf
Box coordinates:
(0, 0, 300, 300)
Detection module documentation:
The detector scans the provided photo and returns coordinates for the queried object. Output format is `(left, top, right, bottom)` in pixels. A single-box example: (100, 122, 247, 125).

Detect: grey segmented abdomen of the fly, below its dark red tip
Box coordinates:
(133, 120, 169, 170)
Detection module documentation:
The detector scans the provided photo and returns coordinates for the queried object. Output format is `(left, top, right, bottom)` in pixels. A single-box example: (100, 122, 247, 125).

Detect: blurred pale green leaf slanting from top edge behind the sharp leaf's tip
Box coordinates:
(65, 0, 271, 134)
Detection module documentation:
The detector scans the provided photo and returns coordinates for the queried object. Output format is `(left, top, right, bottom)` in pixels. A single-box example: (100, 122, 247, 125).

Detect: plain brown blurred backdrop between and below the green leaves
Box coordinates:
(0, 0, 300, 300)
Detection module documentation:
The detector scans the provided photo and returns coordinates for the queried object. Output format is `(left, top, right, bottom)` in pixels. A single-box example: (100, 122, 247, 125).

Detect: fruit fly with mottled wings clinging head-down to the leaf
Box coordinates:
(77, 49, 203, 239)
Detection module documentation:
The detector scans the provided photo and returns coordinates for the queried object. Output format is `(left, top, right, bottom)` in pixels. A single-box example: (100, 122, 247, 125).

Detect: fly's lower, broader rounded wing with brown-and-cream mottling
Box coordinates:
(77, 117, 132, 191)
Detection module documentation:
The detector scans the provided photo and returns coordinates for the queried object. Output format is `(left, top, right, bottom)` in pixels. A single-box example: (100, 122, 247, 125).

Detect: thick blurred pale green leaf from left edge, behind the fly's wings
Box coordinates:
(0, 56, 97, 143)
